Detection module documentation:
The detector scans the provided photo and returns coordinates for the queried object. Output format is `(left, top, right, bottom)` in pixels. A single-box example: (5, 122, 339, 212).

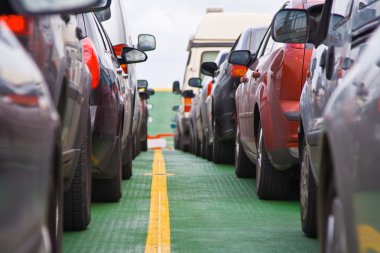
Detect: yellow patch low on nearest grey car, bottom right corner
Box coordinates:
(358, 224, 380, 253)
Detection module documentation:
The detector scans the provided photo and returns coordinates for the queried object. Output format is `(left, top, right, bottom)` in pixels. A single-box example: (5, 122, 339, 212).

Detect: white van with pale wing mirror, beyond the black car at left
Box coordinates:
(96, 0, 156, 170)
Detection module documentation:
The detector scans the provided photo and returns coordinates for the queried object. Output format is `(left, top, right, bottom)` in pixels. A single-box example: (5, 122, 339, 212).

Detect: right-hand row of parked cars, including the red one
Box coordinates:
(173, 0, 380, 252)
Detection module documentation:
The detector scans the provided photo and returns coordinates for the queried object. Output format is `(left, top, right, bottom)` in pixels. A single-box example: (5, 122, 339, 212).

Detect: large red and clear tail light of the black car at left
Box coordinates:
(82, 37, 100, 90)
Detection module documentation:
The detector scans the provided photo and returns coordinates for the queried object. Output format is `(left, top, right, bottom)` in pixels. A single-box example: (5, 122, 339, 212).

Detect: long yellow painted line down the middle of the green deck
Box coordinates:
(145, 150, 170, 253)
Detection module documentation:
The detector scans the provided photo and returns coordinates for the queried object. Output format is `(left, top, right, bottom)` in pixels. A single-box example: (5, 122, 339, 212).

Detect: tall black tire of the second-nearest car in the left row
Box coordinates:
(63, 112, 92, 230)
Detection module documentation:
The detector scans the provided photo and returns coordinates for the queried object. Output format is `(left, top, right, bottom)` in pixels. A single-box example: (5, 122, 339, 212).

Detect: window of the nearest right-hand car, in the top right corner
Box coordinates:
(353, 0, 380, 31)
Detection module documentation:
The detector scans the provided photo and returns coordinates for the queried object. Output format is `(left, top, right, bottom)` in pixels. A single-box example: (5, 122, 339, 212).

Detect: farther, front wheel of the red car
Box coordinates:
(235, 128, 256, 178)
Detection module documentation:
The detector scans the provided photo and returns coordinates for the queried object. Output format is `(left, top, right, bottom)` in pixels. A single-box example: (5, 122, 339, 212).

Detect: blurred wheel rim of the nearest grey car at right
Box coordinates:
(325, 197, 347, 253)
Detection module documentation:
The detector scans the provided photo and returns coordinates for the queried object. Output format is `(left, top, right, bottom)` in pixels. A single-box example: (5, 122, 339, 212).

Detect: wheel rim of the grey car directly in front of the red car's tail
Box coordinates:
(300, 146, 310, 220)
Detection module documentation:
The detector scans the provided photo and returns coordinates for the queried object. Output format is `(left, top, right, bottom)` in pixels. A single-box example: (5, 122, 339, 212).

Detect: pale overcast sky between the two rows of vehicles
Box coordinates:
(125, 0, 285, 88)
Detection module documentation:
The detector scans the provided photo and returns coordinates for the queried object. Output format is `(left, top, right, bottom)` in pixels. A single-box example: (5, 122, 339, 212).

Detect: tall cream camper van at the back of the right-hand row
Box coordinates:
(174, 9, 270, 153)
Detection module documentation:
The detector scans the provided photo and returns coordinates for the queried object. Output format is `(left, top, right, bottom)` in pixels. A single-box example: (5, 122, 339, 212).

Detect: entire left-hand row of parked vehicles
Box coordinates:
(0, 0, 156, 252)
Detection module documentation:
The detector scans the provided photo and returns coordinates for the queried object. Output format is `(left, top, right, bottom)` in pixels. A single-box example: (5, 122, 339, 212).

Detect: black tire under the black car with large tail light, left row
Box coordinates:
(92, 138, 122, 202)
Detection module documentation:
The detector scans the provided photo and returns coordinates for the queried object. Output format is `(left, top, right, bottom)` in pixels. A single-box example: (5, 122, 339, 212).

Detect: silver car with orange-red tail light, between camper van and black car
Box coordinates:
(189, 50, 228, 161)
